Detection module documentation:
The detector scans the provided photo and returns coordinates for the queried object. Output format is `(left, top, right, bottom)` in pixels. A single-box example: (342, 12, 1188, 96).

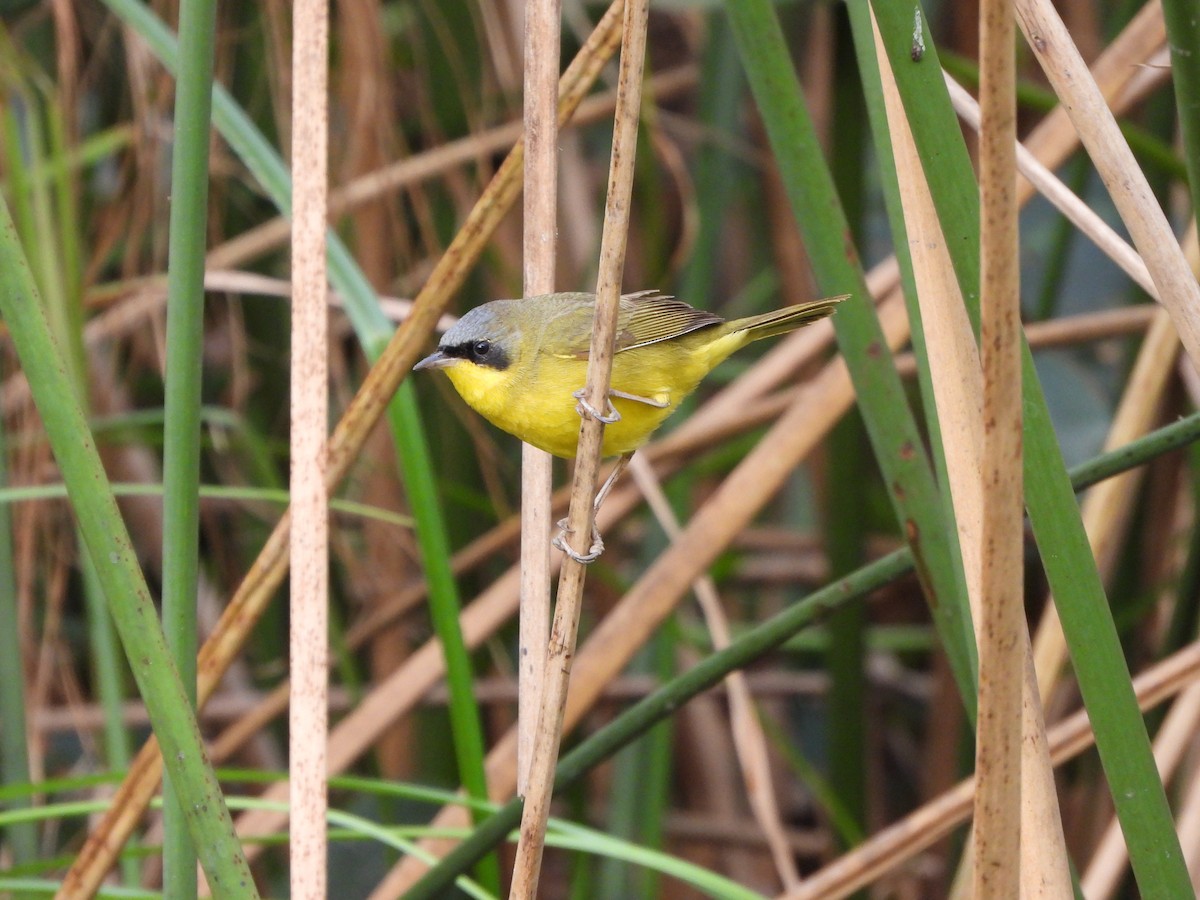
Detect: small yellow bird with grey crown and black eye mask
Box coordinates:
(414, 290, 848, 562)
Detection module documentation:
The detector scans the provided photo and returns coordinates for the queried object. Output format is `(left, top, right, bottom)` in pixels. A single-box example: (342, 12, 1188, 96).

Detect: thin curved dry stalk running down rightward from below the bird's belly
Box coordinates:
(629, 456, 800, 890)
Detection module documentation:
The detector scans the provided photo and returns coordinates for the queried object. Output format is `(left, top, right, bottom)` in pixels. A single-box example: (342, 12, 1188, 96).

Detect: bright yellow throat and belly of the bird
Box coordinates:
(446, 342, 727, 458)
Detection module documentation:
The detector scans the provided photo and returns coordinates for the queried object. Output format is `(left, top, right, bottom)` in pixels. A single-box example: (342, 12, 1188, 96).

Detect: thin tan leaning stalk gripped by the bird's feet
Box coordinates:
(510, 0, 649, 899)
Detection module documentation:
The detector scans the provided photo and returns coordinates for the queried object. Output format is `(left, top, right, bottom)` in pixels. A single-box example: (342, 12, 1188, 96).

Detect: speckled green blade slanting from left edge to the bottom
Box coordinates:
(0, 205, 257, 898)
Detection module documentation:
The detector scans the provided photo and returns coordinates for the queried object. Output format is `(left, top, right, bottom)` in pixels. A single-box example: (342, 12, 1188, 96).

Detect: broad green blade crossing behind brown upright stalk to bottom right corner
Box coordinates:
(872, 2, 1190, 896)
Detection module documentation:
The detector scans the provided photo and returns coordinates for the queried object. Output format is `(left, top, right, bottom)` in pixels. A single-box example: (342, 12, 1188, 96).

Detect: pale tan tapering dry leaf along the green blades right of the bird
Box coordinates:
(876, 12, 1070, 895)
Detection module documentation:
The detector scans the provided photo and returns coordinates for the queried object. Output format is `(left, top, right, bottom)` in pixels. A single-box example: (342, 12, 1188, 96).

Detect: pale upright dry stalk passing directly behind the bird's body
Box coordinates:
(517, 0, 562, 797)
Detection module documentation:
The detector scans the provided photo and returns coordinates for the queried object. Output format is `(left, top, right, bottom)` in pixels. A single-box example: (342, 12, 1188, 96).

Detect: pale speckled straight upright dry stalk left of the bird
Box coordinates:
(288, 0, 329, 900)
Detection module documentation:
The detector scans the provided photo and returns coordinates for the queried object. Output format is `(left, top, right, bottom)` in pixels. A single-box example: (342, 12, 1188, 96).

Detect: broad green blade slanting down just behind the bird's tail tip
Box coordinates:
(726, 0, 978, 719)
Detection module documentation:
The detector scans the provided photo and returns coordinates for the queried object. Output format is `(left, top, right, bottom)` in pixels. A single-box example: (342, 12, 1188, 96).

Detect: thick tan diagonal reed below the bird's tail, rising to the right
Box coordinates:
(372, 293, 908, 900)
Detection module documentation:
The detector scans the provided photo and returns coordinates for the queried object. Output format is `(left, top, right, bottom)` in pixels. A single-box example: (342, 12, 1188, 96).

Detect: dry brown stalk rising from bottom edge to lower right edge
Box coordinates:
(786, 643, 1200, 900)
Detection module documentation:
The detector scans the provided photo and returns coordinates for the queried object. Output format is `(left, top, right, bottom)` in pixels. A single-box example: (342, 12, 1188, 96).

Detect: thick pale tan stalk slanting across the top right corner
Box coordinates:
(1014, 0, 1200, 366)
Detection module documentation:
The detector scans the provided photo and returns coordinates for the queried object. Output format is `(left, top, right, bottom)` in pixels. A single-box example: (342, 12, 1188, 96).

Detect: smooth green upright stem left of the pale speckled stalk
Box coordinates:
(162, 0, 216, 900)
